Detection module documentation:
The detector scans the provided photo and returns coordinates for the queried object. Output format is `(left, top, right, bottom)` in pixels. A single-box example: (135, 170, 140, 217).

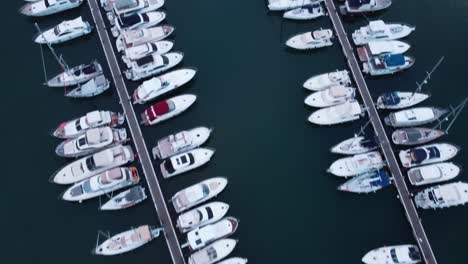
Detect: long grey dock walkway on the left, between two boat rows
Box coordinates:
(88, 0, 185, 264)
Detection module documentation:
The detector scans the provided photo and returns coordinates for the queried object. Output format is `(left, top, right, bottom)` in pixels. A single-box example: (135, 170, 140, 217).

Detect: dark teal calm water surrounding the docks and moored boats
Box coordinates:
(0, 0, 468, 264)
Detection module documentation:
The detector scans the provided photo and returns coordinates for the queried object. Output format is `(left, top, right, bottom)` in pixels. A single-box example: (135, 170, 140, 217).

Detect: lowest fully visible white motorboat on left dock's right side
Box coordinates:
(188, 238, 237, 264)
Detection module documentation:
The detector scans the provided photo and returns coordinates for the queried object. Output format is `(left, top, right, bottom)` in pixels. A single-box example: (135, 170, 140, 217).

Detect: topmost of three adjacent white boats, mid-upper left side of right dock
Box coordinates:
(303, 70, 351, 91)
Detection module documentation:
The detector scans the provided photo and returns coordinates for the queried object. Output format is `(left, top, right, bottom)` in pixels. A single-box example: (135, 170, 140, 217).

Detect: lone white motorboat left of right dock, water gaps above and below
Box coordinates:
(286, 29, 333, 50)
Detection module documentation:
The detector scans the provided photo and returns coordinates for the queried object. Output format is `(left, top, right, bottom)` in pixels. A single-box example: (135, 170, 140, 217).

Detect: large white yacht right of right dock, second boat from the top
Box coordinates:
(352, 20, 416, 45)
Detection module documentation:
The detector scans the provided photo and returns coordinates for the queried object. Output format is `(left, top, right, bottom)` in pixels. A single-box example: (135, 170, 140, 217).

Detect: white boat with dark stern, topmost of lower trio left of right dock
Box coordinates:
(331, 136, 378, 155)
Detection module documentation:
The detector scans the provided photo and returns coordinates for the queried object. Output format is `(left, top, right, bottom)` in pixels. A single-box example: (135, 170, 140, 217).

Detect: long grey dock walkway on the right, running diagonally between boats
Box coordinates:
(325, 0, 437, 264)
